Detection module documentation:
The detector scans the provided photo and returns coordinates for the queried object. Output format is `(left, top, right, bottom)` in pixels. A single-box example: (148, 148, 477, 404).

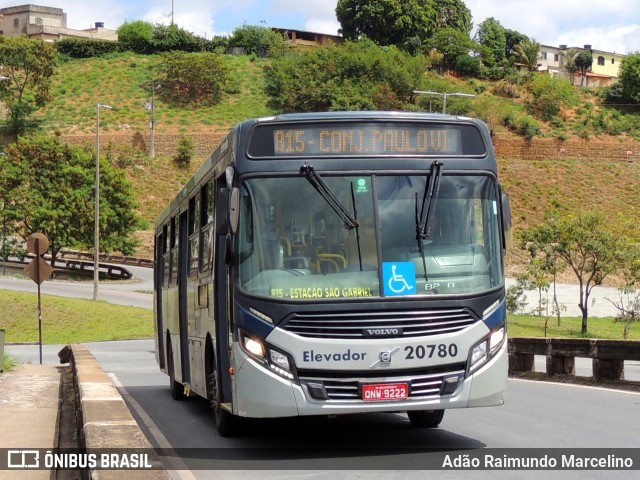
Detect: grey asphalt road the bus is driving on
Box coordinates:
(8, 340, 640, 480)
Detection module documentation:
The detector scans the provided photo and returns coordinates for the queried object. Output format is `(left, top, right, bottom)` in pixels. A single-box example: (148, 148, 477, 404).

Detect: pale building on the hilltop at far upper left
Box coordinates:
(0, 5, 118, 42)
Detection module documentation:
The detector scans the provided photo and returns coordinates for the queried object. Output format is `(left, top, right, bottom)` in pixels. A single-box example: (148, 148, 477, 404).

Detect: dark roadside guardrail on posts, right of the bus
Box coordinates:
(508, 337, 640, 381)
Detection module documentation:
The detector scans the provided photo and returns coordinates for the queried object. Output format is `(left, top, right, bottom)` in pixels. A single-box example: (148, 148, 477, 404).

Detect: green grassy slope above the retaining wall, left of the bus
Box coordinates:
(33, 53, 273, 135)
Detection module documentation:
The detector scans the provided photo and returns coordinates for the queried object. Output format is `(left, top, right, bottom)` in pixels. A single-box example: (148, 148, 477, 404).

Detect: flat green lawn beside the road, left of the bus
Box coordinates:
(0, 290, 153, 345)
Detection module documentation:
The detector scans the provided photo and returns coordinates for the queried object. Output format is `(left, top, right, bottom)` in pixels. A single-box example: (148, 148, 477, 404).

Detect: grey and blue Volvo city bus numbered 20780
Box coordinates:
(154, 112, 511, 436)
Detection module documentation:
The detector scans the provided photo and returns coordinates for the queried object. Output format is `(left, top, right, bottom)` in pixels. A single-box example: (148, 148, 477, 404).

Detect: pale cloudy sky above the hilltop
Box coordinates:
(0, 0, 640, 54)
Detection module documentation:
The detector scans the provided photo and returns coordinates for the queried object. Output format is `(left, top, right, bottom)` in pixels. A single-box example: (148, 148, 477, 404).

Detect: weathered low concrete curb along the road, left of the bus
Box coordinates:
(58, 345, 170, 480)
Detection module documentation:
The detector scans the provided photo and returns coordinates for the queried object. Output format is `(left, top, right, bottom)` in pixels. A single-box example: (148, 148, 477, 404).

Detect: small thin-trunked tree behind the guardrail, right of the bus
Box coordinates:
(522, 211, 639, 334)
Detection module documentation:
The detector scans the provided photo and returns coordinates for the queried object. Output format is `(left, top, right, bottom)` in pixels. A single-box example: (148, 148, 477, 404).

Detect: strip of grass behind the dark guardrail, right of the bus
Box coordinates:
(508, 315, 640, 340)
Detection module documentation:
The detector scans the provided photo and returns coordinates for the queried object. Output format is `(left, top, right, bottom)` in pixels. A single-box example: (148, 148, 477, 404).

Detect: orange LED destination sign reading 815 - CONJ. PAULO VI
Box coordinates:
(248, 123, 485, 158)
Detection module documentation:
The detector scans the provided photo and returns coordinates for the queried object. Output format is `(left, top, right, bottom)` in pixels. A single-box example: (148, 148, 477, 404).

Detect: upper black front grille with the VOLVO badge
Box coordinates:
(280, 308, 477, 339)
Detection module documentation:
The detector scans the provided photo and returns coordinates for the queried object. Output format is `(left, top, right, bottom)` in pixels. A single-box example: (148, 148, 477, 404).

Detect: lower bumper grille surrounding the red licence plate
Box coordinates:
(298, 364, 465, 401)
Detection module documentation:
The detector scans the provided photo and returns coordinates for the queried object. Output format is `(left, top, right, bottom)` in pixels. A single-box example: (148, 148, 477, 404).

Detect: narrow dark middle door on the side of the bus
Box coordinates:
(178, 211, 191, 383)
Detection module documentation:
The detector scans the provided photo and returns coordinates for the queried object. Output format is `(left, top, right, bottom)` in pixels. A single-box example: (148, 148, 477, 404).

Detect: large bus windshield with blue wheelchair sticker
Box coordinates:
(235, 173, 503, 301)
